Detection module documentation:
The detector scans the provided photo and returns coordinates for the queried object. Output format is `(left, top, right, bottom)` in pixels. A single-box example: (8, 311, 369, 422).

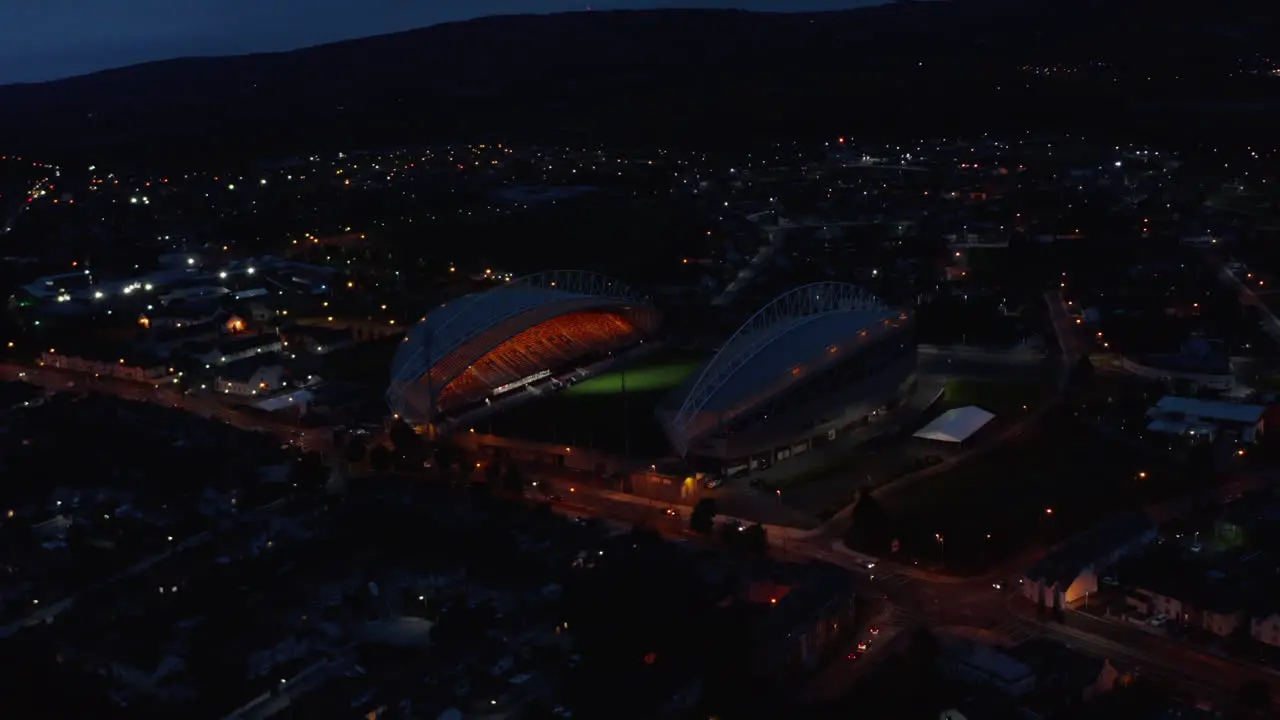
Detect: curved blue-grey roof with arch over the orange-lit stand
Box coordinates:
(387, 270, 657, 420)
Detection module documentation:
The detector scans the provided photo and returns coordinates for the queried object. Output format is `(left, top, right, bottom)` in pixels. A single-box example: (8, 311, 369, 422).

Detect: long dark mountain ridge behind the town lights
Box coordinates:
(0, 0, 1280, 162)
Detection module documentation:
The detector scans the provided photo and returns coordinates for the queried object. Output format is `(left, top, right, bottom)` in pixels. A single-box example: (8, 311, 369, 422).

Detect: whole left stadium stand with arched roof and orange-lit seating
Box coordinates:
(387, 270, 660, 425)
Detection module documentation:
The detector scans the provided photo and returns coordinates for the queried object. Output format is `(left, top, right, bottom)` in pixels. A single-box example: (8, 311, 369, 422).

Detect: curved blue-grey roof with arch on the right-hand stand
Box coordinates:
(666, 282, 900, 455)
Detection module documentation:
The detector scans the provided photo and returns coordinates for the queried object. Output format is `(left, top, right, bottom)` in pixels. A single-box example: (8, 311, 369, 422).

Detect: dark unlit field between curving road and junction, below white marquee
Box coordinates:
(883, 409, 1193, 571)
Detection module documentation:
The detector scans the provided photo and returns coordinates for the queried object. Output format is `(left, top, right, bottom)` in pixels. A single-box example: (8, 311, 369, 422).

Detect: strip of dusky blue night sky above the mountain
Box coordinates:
(0, 0, 883, 83)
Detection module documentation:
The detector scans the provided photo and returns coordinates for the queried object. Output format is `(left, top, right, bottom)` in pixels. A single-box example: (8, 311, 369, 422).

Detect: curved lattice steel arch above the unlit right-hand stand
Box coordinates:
(669, 282, 886, 455)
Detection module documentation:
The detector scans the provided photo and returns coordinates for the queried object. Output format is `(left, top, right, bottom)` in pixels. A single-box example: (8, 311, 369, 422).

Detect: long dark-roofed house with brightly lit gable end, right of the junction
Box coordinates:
(1021, 512, 1156, 609)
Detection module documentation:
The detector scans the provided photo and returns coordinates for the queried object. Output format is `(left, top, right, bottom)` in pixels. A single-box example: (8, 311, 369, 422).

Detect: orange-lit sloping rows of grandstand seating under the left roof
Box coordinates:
(438, 311, 641, 410)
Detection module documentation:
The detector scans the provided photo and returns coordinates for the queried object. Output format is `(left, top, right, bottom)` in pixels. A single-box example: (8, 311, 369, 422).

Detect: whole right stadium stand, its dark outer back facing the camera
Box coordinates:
(658, 282, 916, 473)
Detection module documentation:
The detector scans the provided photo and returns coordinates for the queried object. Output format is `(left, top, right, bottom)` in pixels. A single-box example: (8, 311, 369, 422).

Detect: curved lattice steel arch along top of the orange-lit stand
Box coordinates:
(387, 270, 648, 414)
